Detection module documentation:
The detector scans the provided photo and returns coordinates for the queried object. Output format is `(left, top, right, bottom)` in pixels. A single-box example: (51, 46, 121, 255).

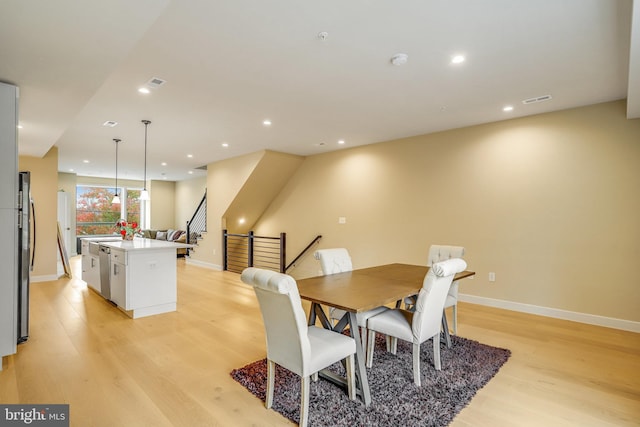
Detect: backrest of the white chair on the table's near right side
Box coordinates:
(411, 258, 467, 342)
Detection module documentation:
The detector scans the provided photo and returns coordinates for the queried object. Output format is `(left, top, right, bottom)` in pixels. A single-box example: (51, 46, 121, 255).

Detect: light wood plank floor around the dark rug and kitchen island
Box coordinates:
(0, 257, 640, 427)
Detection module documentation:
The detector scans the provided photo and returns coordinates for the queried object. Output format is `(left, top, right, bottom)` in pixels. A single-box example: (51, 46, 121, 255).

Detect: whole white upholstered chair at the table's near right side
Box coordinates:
(367, 258, 467, 386)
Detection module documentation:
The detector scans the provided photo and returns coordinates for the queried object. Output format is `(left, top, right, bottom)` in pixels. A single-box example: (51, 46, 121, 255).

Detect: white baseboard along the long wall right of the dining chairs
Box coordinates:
(458, 294, 640, 332)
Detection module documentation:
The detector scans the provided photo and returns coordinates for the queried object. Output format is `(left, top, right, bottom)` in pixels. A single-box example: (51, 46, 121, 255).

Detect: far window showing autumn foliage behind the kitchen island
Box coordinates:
(76, 185, 142, 236)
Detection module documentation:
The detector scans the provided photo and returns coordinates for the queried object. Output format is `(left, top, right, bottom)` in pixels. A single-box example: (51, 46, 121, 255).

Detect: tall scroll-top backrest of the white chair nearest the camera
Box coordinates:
(241, 267, 311, 376)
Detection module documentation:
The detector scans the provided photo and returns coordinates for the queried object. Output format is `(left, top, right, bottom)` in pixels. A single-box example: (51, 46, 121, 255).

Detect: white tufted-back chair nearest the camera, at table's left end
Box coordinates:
(241, 267, 356, 426)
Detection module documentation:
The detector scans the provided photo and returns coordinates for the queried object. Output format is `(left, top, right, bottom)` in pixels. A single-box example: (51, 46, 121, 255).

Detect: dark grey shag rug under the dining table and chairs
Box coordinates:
(231, 334, 511, 427)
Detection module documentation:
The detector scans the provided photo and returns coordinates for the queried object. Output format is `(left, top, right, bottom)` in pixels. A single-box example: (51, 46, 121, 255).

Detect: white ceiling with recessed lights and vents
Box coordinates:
(0, 0, 640, 180)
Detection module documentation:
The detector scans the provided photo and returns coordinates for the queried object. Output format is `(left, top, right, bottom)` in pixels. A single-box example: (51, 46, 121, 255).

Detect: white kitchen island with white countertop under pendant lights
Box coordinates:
(102, 238, 191, 319)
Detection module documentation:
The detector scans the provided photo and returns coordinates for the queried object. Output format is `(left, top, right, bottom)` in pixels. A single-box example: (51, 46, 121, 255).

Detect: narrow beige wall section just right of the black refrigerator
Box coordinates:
(18, 147, 58, 281)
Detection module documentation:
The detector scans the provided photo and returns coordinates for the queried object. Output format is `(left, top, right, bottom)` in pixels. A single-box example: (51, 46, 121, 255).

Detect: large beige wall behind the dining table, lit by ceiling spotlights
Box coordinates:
(251, 102, 640, 322)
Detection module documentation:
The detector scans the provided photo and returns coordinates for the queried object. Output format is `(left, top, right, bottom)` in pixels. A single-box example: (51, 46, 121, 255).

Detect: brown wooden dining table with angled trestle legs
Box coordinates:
(297, 263, 475, 406)
